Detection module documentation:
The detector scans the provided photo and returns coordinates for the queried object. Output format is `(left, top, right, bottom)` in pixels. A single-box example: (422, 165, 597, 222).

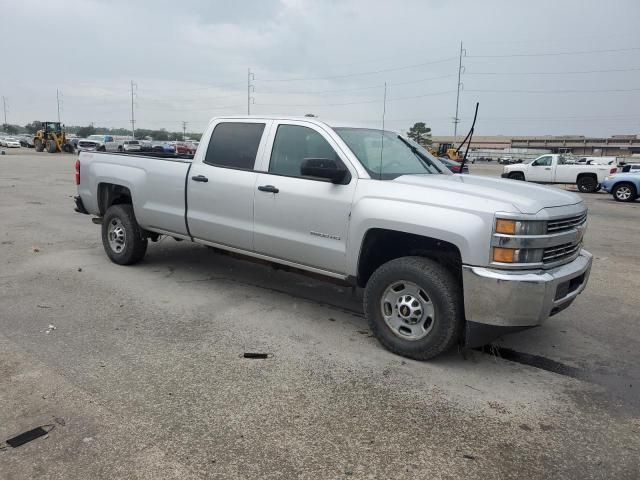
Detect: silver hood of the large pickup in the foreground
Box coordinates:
(393, 174, 582, 214)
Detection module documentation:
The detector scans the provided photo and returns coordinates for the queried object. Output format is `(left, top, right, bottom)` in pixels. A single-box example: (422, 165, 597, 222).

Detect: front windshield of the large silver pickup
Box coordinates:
(334, 128, 449, 180)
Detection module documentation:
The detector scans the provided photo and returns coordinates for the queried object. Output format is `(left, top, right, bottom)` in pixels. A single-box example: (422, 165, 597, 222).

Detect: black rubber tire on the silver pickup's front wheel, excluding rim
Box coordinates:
(364, 257, 464, 360)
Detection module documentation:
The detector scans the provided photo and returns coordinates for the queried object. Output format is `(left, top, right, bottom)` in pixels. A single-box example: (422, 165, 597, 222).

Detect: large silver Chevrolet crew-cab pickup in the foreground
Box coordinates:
(75, 117, 592, 360)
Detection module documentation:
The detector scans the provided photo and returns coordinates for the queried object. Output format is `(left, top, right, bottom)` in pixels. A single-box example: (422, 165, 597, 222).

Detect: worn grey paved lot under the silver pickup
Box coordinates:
(0, 149, 640, 479)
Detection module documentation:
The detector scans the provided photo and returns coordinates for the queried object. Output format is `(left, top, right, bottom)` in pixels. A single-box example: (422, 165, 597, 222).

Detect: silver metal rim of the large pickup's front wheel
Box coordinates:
(380, 280, 435, 341)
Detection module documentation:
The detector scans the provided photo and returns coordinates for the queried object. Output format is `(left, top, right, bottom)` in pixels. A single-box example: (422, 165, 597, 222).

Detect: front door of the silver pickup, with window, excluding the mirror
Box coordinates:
(254, 120, 357, 273)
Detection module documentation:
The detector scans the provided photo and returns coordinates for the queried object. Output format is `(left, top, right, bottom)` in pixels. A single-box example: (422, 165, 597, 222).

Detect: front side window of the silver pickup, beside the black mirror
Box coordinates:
(269, 125, 342, 177)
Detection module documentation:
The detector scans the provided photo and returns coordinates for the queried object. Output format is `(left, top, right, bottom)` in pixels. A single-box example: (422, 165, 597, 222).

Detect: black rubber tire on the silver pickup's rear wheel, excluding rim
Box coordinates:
(102, 205, 147, 265)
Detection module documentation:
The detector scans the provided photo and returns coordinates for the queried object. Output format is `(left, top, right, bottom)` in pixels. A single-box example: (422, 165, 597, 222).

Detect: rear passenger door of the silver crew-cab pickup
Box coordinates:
(187, 119, 271, 251)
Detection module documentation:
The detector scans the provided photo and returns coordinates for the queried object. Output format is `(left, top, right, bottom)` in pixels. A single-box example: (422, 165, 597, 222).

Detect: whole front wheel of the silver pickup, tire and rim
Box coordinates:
(364, 257, 464, 360)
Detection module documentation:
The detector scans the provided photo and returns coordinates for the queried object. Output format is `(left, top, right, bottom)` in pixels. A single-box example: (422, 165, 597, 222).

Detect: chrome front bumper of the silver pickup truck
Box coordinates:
(462, 250, 593, 329)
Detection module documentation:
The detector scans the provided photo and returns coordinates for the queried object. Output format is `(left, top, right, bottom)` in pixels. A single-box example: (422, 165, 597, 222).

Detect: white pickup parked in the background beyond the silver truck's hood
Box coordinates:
(502, 154, 617, 193)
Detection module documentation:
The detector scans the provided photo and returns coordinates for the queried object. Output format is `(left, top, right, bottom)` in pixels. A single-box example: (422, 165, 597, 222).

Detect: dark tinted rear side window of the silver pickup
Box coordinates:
(204, 122, 265, 170)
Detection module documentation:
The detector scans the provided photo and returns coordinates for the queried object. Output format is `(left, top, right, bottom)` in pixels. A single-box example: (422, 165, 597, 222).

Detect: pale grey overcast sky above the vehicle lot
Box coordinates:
(0, 0, 640, 135)
